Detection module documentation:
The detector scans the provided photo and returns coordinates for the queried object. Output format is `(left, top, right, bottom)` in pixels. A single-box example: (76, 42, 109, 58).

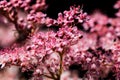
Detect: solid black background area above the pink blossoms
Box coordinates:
(46, 0, 117, 18)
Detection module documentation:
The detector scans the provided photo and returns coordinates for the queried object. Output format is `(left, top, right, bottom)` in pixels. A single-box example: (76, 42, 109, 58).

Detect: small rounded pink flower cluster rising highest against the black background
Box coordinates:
(57, 6, 88, 26)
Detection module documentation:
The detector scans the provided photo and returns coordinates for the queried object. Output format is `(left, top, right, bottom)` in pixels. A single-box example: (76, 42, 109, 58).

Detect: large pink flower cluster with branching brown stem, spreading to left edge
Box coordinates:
(0, 27, 82, 80)
